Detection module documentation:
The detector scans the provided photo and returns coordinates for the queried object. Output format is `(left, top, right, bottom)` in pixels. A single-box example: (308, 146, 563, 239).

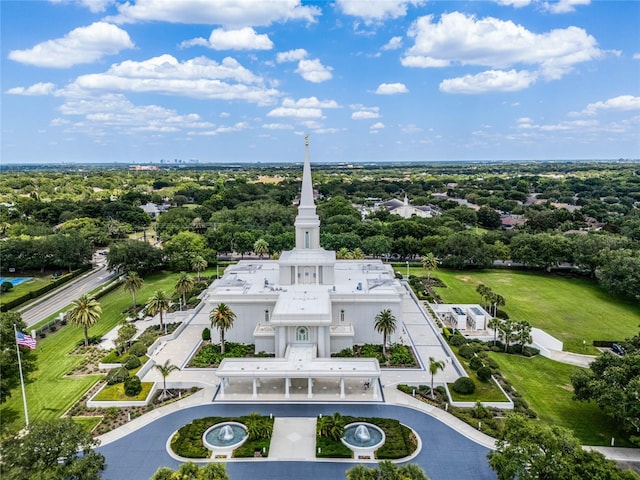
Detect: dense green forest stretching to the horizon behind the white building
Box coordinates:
(0, 161, 640, 300)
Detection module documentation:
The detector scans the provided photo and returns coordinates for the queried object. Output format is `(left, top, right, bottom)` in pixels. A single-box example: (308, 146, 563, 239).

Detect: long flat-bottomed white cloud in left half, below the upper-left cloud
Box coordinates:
(65, 55, 280, 105)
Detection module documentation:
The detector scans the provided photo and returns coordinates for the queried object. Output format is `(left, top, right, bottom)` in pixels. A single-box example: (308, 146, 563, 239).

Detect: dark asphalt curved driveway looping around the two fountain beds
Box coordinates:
(97, 403, 497, 480)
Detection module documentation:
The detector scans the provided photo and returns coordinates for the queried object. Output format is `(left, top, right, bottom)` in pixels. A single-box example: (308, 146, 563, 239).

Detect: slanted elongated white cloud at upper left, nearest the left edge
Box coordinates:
(9, 22, 134, 68)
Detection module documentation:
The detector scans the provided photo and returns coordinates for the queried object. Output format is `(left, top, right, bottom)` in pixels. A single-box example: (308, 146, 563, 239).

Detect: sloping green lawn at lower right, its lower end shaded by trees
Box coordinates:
(489, 352, 629, 446)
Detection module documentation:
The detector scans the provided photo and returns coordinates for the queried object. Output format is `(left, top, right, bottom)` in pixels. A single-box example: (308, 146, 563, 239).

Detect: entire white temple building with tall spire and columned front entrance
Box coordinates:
(206, 137, 407, 398)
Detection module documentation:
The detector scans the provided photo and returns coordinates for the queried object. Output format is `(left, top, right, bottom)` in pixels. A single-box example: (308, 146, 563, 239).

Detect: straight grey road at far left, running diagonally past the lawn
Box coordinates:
(18, 258, 117, 327)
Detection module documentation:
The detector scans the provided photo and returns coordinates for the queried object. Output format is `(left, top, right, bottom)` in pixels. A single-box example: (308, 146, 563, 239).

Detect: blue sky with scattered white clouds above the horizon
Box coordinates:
(0, 0, 640, 163)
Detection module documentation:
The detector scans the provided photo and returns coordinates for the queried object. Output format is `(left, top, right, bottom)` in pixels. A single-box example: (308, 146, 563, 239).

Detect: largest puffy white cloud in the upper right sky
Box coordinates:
(402, 12, 603, 80)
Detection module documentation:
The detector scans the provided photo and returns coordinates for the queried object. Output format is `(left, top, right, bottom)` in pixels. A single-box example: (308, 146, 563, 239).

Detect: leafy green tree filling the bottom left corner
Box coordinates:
(0, 418, 105, 480)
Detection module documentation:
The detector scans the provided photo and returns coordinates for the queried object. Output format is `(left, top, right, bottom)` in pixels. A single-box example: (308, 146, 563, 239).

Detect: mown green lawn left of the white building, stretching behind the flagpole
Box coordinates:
(0, 273, 188, 431)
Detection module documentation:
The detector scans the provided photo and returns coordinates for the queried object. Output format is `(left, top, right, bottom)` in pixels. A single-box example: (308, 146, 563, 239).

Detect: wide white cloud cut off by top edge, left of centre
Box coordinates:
(113, 0, 321, 27)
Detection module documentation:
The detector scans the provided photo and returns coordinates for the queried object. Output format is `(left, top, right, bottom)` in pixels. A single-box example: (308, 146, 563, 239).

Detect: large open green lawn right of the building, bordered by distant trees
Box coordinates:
(430, 268, 640, 354)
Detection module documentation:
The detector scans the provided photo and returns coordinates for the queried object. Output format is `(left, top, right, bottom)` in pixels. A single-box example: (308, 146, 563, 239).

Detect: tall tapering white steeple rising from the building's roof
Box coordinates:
(294, 135, 320, 249)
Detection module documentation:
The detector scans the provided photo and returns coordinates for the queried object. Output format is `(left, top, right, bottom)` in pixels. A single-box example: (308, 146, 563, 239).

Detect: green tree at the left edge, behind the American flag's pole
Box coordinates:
(0, 312, 36, 403)
